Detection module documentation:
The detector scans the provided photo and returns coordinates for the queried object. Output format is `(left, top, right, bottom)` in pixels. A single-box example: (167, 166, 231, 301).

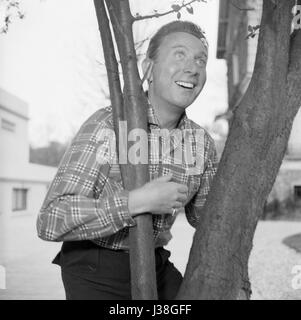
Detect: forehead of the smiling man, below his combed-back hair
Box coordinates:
(159, 32, 207, 53)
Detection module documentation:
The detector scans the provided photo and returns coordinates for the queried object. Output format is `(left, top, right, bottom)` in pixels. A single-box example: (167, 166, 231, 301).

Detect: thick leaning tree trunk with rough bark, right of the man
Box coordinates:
(177, 0, 301, 299)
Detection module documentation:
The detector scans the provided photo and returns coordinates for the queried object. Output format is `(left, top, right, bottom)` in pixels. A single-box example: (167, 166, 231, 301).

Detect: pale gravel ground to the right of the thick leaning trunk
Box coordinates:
(249, 221, 301, 300)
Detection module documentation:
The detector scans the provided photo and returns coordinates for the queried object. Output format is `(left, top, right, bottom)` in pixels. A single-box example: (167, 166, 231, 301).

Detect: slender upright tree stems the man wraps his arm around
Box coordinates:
(94, 0, 157, 300)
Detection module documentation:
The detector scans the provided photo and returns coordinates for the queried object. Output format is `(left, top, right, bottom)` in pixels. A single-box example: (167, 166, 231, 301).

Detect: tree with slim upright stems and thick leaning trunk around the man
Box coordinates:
(94, 0, 301, 299)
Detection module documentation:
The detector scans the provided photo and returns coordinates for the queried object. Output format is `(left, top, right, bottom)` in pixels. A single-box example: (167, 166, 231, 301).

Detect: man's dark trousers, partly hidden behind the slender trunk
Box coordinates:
(53, 241, 183, 300)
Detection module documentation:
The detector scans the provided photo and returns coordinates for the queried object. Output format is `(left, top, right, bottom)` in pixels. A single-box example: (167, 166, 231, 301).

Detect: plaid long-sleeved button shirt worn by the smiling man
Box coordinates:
(37, 105, 217, 250)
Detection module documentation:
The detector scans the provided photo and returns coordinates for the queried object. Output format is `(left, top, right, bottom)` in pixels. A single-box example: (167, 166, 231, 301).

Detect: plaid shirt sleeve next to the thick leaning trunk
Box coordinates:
(185, 132, 218, 228)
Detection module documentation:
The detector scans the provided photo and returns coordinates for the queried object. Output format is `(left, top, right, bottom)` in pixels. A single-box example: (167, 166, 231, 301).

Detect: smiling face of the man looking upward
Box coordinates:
(149, 32, 207, 109)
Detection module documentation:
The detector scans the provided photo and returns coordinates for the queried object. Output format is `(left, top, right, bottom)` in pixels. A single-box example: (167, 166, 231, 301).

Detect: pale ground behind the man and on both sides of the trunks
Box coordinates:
(0, 215, 301, 300)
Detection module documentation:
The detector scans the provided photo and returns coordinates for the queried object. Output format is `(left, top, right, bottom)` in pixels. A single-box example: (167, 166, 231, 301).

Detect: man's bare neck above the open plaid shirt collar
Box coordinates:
(149, 90, 183, 130)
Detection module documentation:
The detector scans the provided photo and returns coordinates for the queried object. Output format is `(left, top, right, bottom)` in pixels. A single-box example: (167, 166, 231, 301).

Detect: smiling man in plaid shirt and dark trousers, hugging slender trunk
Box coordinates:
(37, 21, 217, 299)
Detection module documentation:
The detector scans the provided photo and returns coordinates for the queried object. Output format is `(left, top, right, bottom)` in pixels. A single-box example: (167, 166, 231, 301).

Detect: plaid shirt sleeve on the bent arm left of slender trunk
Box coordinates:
(37, 109, 136, 241)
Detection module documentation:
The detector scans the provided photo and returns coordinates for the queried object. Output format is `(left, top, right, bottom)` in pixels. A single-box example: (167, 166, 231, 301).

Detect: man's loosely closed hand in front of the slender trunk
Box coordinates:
(128, 175, 188, 216)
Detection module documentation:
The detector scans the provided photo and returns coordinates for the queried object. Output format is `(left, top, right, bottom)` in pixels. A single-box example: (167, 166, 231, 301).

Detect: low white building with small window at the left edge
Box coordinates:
(0, 88, 57, 264)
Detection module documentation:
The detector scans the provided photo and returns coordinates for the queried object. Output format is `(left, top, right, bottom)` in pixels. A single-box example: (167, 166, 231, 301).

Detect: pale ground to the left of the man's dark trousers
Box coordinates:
(0, 212, 65, 300)
